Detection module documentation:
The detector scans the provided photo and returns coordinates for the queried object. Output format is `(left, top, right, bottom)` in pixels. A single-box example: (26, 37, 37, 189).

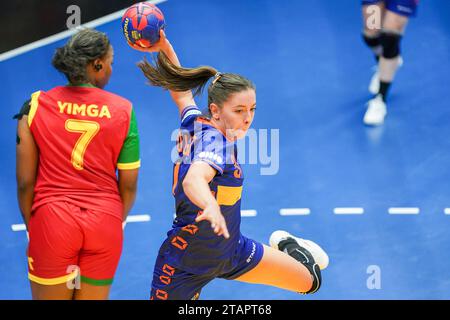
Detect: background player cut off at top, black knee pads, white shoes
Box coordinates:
(362, 0, 419, 126)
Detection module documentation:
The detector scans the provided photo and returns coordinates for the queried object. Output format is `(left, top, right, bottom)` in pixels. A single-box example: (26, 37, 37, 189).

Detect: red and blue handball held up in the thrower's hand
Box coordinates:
(122, 2, 165, 48)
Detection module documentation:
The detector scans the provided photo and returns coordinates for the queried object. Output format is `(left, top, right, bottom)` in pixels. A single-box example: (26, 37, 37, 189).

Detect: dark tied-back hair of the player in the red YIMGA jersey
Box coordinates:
(52, 29, 110, 84)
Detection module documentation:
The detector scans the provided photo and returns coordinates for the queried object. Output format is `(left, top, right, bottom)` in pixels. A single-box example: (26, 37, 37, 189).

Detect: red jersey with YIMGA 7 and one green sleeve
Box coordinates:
(28, 85, 140, 218)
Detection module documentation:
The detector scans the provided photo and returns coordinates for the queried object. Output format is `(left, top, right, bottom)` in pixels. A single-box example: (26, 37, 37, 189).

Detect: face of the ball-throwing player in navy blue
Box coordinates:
(220, 89, 256, 139)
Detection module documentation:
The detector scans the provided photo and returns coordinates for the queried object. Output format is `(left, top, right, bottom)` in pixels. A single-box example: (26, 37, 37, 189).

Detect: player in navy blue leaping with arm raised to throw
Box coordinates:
(135, 31, 328, 300)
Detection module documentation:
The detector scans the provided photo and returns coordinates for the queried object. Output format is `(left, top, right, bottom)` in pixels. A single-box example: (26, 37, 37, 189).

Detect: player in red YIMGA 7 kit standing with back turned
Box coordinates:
(16, 29, 140, 299)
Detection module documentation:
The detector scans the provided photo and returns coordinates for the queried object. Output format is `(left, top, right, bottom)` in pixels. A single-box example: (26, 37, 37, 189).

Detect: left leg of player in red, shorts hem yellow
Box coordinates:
(28, 202, 82, 300)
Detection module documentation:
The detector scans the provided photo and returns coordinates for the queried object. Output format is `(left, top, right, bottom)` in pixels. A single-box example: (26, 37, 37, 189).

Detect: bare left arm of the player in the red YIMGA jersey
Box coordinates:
(16, 116, 39, 230)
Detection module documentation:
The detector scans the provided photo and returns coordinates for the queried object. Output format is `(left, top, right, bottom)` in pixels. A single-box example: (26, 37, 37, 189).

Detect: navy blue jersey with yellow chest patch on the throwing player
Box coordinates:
(160, 106, 244, 274)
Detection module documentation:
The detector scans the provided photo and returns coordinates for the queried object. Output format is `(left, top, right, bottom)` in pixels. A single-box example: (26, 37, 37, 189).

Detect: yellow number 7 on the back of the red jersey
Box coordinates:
(65, 119, 100, 170)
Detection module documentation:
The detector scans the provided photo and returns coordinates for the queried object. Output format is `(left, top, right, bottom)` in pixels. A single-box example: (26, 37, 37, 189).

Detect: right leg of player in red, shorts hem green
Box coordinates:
(74, 209, 123, 300)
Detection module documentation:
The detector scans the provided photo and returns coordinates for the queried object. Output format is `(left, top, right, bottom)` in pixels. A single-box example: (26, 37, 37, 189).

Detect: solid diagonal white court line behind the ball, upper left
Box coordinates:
(0, 0, 167, 62)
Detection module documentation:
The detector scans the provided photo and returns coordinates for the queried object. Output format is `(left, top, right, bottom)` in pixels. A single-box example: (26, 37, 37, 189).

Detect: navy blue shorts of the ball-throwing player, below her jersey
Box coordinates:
(150, 236, 264, 300)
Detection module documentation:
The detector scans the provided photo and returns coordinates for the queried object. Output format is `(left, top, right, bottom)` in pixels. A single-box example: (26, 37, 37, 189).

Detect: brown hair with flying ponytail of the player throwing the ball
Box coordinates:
(138, 52, 255, 111)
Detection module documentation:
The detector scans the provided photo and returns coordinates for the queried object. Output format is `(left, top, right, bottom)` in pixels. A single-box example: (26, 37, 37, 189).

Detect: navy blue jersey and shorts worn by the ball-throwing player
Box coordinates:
(151, 106, 264, 300)
